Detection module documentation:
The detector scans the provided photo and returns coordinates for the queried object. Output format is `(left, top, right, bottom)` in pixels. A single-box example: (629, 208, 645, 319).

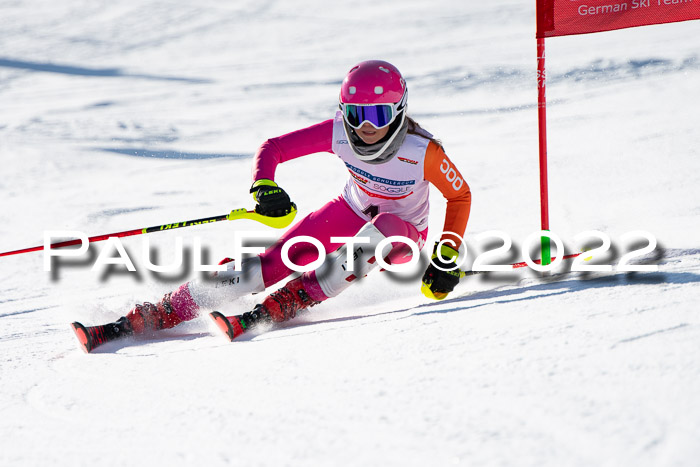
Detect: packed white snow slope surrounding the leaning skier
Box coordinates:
(0, 0, 700, 466)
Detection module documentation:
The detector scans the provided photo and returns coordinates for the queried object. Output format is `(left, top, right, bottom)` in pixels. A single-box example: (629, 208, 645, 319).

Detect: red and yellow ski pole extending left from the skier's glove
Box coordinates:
(0, 205, 297, 256)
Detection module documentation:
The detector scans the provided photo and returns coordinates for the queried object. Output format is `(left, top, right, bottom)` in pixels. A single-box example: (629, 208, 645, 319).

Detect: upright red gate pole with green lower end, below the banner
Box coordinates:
(537, 37, 552, 265)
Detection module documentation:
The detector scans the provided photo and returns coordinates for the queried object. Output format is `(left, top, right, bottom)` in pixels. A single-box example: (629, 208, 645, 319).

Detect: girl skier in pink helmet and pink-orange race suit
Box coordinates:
(74, 60, 471, 351)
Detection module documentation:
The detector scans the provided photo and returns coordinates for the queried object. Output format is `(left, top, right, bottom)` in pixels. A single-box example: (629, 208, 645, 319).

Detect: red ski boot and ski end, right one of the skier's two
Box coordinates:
(209, 277, 321, 341)
